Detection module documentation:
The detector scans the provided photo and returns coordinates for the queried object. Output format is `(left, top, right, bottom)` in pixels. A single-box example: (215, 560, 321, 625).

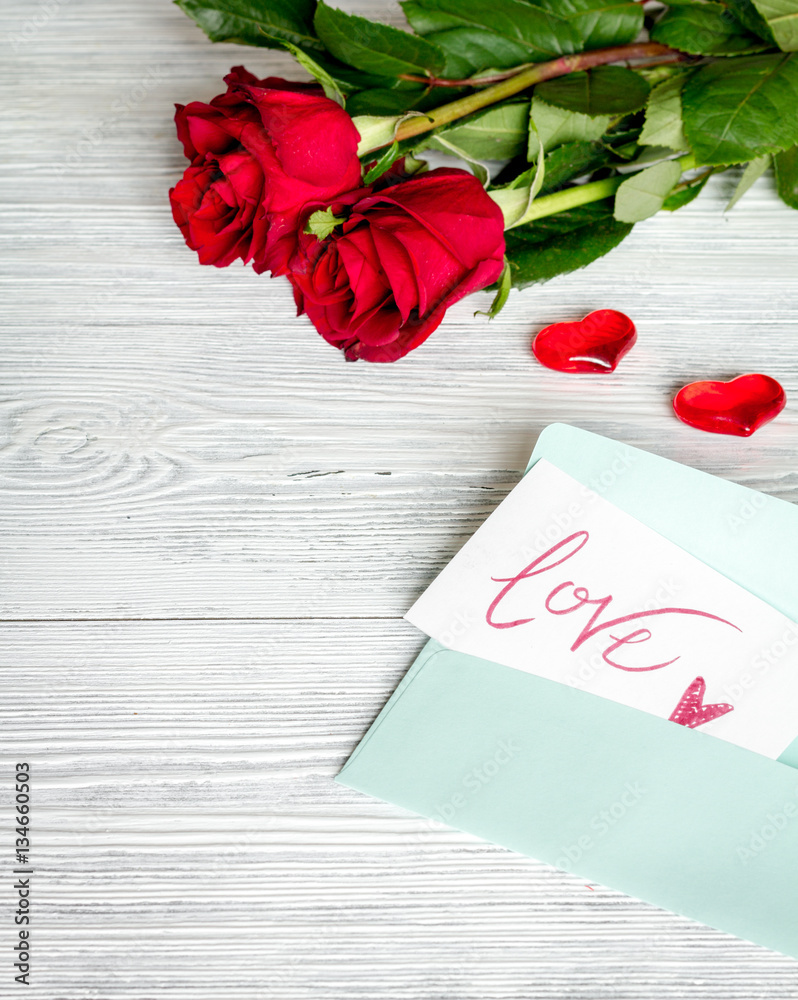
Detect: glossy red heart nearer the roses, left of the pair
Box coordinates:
(532, 309, 637, 374)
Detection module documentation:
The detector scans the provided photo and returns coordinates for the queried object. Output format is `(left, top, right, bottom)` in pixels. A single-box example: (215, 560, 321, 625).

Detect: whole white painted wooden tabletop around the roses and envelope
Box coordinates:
(0, 0, 798, 1000)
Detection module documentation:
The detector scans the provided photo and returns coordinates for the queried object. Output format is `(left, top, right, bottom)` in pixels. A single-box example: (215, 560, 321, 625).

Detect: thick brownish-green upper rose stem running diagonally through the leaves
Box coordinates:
(390, 42, 689, 149)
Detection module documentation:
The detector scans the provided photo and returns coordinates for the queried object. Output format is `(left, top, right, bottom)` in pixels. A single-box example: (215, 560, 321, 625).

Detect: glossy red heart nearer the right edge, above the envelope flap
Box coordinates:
(673, 375, 787, 437)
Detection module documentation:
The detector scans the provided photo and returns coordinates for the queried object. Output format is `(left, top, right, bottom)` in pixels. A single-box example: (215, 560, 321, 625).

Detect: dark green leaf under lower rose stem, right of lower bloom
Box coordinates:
(505, 199, 633, 288)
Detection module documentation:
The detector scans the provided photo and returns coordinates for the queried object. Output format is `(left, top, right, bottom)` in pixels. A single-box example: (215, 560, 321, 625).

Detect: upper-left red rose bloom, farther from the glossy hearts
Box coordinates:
(169, 66, 362, 274)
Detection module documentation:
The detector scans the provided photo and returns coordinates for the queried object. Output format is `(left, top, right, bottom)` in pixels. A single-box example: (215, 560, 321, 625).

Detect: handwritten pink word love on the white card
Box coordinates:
(485, 531, 742, 673)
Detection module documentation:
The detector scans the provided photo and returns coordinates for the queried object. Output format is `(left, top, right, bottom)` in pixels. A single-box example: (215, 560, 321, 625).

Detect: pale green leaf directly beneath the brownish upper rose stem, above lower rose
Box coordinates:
(416, 101, 529, 160)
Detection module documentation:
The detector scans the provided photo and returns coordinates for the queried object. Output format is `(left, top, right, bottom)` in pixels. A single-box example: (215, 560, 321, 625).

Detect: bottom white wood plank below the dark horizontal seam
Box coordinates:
(0, 621, 798, 1000)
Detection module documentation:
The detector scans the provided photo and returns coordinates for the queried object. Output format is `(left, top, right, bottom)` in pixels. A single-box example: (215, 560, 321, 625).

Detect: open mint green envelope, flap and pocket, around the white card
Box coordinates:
(337, 424, 798, 957)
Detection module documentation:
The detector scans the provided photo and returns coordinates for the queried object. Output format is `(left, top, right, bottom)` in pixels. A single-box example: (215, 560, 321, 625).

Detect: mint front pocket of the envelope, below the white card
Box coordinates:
(338, 642, 798, 955)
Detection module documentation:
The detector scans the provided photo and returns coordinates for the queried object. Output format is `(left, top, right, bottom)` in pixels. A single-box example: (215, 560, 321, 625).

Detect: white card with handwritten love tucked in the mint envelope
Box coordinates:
(405, 459, 798, 758)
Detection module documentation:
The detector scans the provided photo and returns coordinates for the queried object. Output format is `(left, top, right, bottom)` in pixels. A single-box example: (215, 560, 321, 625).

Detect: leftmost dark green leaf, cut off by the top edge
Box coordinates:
(175, 0, 324, 51)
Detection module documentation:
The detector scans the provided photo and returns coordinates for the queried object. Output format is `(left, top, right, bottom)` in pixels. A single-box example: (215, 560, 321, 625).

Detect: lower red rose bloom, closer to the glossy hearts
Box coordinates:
(289, 167, 504, 361)
